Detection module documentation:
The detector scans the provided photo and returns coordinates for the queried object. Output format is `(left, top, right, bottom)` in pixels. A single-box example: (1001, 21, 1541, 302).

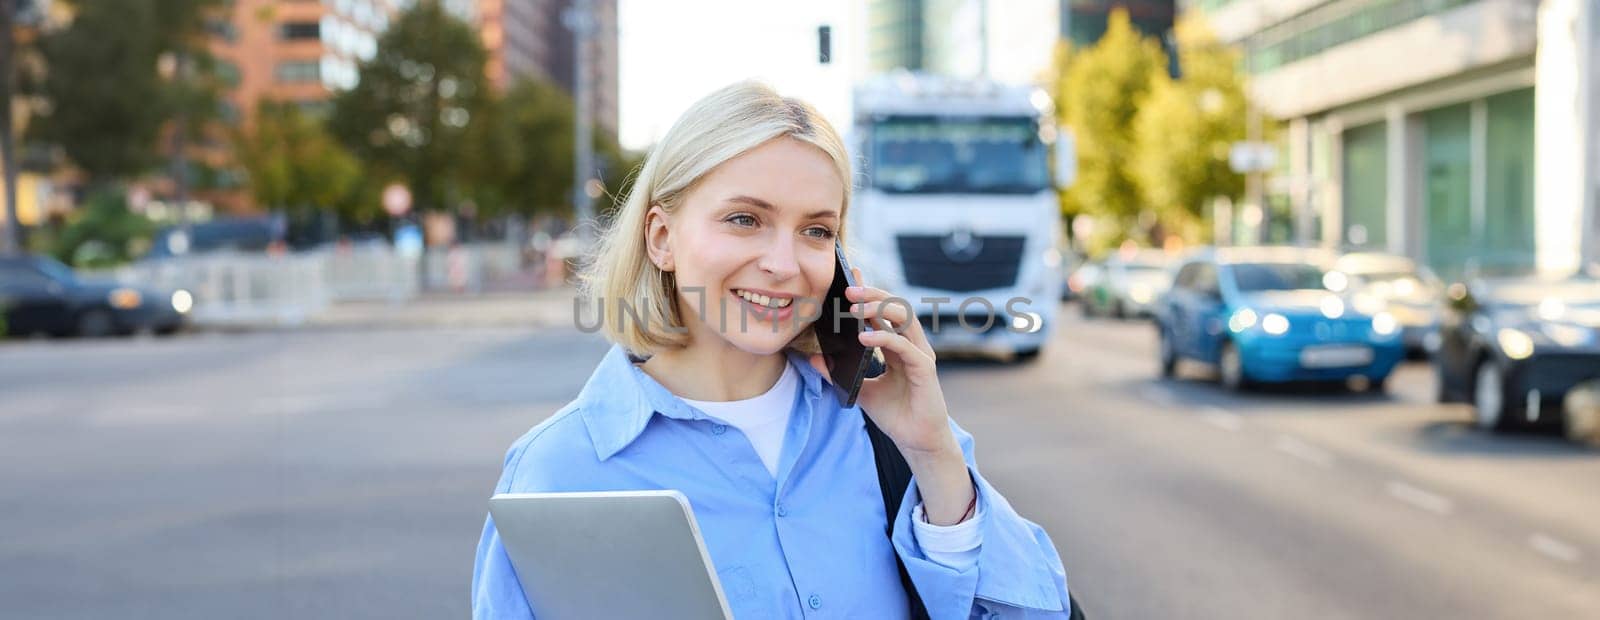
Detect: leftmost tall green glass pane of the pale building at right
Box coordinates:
(1342, 123, 1389, 248)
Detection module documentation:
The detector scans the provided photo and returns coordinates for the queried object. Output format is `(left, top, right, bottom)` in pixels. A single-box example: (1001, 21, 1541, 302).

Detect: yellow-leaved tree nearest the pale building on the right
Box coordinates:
(1133, 18, 1246, 238)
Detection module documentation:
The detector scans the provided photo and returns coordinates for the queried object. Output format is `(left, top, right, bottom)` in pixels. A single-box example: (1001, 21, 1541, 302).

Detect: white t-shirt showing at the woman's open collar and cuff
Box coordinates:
(678, 356, 982, 570)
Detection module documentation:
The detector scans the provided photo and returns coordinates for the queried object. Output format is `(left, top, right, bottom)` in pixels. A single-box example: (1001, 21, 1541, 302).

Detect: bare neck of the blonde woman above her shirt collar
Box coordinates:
(640, 338, 789, 401)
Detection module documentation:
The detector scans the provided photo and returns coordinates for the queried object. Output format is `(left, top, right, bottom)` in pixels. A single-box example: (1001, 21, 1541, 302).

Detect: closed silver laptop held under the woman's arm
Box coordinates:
(490, 491, 733, 620)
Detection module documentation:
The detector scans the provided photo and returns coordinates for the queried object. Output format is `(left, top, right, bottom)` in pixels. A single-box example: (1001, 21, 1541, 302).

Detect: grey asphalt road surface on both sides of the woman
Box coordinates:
(0, 308, 1600, 618)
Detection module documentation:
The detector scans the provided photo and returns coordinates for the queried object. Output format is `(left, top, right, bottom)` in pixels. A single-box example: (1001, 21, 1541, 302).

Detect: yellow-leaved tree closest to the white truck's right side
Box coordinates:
(1056, 8, 1166, 244)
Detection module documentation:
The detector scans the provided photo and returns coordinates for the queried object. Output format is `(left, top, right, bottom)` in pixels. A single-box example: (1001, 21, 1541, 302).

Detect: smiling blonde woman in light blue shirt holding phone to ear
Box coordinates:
(472, 83, 1070, 618)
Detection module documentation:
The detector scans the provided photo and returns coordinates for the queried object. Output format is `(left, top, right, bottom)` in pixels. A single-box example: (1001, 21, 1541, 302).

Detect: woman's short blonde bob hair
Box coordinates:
(579, 81, 853, 358)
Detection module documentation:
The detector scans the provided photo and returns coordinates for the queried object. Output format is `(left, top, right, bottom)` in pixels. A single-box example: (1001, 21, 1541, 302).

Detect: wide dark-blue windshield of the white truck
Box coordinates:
(869, 117, 1050, 193)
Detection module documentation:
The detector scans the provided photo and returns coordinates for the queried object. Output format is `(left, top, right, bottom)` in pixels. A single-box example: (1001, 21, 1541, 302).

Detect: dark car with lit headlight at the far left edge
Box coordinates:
(0, 256, 194, 337)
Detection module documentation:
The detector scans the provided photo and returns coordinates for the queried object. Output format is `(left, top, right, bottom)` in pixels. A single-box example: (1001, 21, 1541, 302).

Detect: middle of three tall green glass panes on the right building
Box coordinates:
(1421, 104, 1474, 272)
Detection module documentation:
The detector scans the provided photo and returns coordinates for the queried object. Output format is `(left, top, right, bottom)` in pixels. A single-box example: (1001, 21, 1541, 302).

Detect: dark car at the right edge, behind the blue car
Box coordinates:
(1434, 275, 1600, 436)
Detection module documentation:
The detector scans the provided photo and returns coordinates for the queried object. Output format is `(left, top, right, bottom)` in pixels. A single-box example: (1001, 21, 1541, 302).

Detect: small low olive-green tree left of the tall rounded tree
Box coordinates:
(235, 101, 366, 221)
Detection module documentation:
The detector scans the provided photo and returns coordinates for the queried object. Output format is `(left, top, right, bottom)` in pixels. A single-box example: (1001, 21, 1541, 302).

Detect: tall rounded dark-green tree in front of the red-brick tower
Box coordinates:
(328, 0, 490, 217)
